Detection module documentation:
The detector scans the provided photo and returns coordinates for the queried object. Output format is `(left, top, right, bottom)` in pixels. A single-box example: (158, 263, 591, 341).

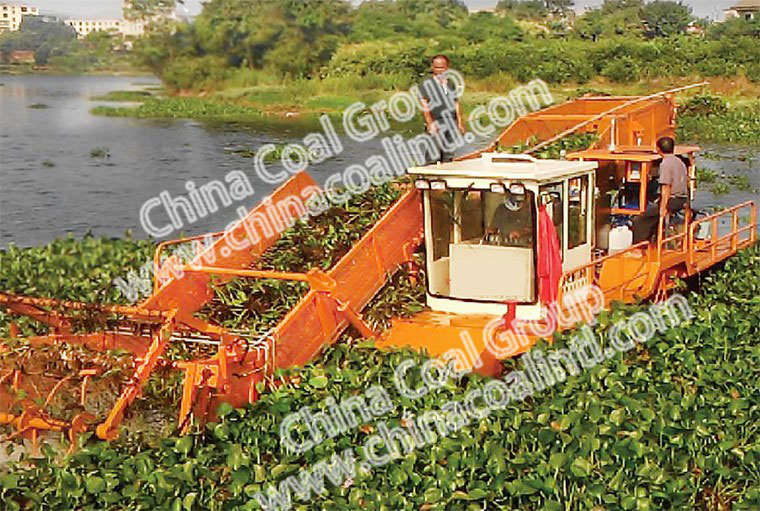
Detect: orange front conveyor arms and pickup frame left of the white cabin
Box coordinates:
(0, 172, 422, 439)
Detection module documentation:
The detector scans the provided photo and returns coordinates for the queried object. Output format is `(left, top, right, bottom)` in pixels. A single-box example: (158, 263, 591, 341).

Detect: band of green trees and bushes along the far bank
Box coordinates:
(119, 0, 760, 89)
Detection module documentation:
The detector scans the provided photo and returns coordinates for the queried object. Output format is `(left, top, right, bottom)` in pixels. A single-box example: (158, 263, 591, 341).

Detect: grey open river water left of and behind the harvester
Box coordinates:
(0, 75, 760, 247)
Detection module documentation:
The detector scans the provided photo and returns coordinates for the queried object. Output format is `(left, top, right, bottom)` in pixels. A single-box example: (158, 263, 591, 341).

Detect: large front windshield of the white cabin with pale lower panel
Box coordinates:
(425, 191, 536, 303)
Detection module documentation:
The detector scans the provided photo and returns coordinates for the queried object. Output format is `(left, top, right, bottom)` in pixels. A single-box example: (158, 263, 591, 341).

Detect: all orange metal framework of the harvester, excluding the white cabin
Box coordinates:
(0, 91, 757, 447)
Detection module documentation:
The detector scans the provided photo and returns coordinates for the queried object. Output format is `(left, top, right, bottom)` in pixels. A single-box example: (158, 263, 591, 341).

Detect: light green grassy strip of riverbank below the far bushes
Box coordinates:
(93, 75, 760, 143)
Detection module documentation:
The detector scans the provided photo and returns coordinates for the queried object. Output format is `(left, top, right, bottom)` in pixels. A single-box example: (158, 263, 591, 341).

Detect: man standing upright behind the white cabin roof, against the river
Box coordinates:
(420, 55, 464, 163)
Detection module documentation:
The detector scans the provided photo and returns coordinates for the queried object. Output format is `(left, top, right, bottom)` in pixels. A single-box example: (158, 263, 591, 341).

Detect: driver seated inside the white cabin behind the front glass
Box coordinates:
(486, 193, 533, 247)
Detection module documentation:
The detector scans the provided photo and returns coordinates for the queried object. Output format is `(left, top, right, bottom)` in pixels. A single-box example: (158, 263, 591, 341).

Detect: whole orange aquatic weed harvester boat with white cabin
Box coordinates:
(0, 86, 757, 446)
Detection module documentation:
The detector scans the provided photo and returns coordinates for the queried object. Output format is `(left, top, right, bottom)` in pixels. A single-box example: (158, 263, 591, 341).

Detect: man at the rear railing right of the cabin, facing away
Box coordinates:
(633, 137, 689, 243)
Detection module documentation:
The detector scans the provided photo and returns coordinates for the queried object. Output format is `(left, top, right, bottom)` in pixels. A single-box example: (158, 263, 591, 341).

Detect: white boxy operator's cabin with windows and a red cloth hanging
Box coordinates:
(409, 153, 597, 319)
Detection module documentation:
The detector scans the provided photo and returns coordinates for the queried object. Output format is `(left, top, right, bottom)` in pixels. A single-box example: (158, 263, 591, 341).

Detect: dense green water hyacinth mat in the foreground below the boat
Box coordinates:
(0, 241, 760, 511)
